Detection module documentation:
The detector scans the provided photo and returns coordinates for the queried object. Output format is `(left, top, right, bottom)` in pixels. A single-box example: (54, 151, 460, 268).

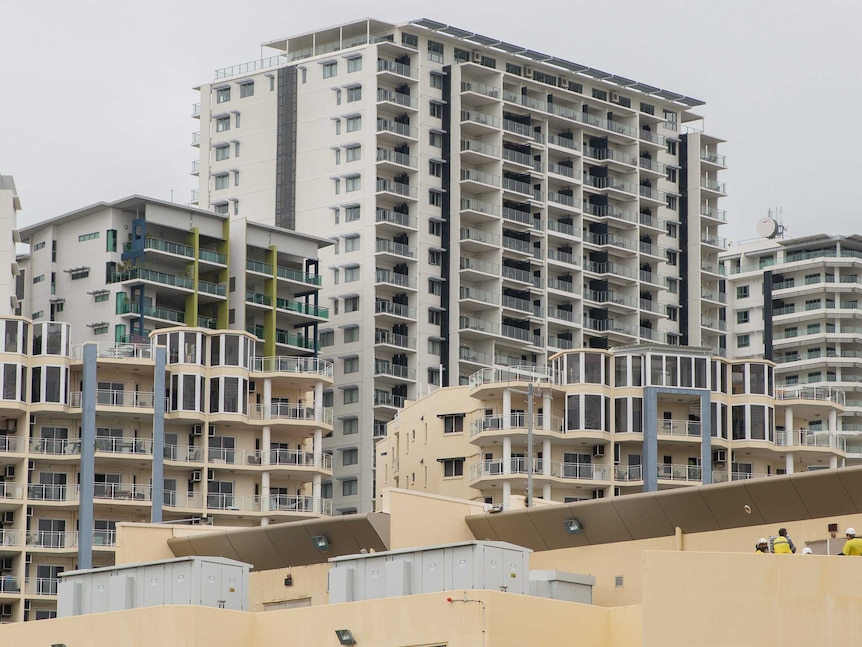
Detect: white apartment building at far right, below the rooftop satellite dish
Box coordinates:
(721, 234, 862, 454)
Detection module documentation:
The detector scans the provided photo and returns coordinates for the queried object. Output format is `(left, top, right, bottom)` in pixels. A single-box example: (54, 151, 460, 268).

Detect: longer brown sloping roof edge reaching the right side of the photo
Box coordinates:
(465, 466, 862, 551)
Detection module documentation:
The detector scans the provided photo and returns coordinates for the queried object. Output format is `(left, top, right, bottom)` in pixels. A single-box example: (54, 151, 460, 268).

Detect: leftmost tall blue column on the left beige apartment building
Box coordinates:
(78, 343, 98, 569)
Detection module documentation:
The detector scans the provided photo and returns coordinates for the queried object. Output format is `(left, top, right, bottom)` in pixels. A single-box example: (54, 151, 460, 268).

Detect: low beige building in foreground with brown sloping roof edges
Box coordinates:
(0, 468, 862, 647)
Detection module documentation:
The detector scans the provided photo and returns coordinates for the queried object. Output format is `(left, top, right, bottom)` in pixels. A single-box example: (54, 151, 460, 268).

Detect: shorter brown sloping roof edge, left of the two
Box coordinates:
(168, 512, 390, 571)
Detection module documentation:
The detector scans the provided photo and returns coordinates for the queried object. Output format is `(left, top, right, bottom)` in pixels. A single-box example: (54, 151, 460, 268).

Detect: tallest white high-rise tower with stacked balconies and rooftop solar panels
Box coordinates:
(193, 19, 725, 513)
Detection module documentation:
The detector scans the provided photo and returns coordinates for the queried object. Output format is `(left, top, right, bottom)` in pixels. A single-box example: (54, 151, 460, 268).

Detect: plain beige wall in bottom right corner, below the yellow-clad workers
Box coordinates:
(643, 552, 862, 647)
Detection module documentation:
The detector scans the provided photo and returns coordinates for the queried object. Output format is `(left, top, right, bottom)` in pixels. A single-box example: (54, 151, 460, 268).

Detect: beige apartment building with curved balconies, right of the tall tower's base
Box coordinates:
(377, 345, 862, 510)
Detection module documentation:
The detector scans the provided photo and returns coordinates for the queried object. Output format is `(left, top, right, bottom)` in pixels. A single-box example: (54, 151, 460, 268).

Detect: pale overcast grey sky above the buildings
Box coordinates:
(0, 0, 862, 241)
